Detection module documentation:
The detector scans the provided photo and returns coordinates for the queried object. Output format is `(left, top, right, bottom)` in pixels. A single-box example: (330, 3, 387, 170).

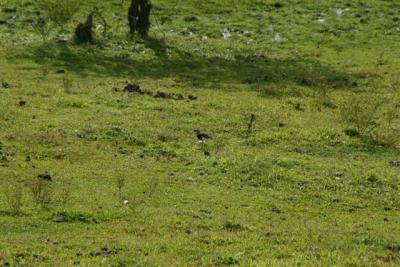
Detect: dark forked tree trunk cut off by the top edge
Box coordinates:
(128, 0, 152, 36)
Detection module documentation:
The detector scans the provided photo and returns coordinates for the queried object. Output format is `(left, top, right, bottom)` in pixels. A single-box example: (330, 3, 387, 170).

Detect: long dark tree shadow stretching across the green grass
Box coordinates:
(32, 38, 356, 91)
